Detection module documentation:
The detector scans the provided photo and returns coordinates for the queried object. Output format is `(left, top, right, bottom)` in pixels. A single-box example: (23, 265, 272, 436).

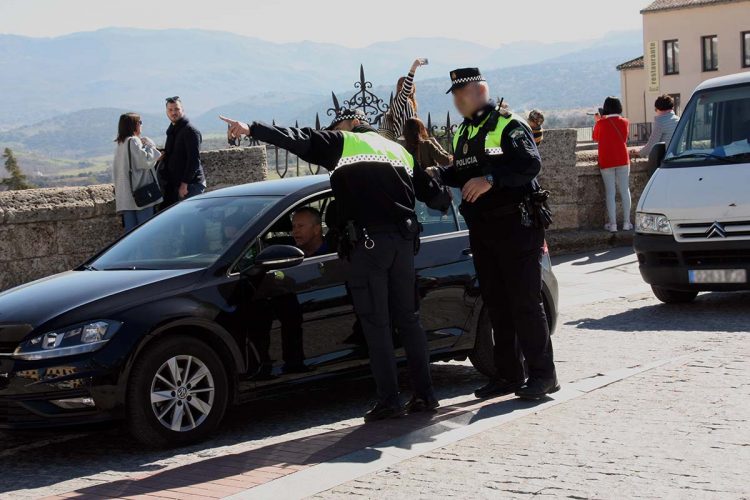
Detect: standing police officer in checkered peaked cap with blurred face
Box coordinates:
(430, 68, 560, 399)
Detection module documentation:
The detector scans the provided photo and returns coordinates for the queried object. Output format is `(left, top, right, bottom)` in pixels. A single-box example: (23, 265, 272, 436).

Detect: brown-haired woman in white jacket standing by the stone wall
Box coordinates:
(112, 113, 162, 231)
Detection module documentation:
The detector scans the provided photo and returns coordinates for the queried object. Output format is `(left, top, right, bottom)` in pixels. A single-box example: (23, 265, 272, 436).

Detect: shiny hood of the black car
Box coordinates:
(0, 269, 196, 328)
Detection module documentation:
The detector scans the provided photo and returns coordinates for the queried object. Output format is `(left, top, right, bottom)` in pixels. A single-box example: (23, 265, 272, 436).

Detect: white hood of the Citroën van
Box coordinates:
(638, 163, 750, 221)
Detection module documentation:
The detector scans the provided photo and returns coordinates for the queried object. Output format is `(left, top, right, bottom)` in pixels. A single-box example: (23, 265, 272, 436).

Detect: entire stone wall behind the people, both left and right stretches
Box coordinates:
(0, 135, 647, 290)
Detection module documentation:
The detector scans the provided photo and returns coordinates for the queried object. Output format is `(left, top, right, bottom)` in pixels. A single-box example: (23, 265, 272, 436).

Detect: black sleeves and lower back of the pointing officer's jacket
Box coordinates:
(250, 122, 450, 227)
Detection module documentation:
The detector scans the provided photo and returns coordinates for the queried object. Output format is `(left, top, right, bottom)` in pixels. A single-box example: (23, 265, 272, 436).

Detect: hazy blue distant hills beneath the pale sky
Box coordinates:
(0, 28, 642, 159)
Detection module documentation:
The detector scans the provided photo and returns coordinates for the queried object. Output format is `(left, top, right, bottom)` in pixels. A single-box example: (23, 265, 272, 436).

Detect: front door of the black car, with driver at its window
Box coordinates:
(238, 193, 366, 388)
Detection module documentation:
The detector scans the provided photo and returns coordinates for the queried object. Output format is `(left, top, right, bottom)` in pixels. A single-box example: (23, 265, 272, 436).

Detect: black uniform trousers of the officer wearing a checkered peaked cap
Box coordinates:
(467, 213, 555, 382)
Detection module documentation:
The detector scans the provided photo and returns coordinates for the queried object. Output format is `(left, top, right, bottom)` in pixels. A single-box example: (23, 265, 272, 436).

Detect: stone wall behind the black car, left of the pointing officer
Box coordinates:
(0, 146, 268, 290)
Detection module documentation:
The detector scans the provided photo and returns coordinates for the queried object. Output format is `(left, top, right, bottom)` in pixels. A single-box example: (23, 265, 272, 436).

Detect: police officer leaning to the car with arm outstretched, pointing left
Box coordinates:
(222, 110, 450, 422)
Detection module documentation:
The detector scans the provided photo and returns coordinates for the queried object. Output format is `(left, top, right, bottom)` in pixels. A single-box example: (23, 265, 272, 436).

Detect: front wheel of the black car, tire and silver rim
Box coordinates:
(126, 335, 229, 447)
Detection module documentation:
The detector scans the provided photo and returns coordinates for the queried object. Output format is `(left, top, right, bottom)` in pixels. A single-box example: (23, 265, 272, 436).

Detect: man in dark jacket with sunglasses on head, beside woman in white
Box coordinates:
(159, 96, 206, 209)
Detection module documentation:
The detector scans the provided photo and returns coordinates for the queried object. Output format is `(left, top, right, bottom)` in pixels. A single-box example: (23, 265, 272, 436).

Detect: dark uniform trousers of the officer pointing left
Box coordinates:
(349, 231, 434, 405)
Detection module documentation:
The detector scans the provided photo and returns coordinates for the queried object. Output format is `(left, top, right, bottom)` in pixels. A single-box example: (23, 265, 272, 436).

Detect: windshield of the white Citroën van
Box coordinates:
(664, 84, 750, 165)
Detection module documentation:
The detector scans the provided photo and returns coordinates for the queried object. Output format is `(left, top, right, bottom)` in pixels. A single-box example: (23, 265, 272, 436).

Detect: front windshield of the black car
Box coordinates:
(91, 196, 279, 270)
